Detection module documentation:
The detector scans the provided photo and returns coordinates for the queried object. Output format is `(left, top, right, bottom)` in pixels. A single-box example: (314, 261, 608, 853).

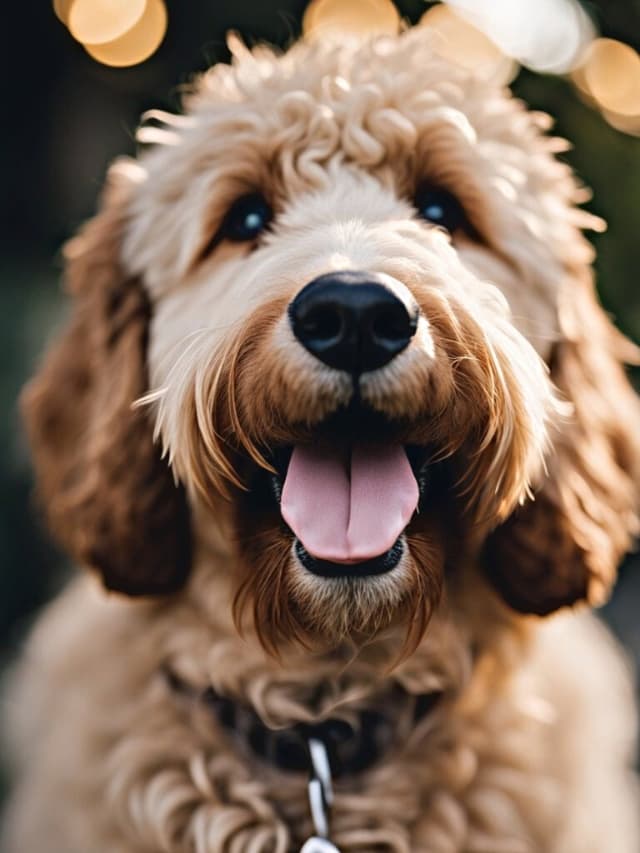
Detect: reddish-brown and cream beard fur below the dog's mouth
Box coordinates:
(234, 516, 443, 657)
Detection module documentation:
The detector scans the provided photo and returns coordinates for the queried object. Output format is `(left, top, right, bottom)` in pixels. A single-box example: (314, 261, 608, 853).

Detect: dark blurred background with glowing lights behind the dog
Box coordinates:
(0, 0, 640, 780)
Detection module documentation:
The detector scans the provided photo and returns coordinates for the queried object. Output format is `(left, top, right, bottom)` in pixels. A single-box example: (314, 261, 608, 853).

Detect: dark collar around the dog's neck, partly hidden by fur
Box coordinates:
(165, 671, 441, 779)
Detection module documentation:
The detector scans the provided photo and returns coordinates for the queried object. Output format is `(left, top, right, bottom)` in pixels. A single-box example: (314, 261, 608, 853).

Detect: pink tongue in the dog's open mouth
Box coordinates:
(280, 445, 419, 563)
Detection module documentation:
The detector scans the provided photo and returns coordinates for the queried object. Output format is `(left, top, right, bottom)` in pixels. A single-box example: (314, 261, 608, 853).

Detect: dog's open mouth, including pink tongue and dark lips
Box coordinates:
(250, 407, 430, 578)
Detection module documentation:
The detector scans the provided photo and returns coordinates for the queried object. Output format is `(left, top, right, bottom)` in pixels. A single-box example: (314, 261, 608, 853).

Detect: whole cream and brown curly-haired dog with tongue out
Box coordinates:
(5, 28, 640, 853)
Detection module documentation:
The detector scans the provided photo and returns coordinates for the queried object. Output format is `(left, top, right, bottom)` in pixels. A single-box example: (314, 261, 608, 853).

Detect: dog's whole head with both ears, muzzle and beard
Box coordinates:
(26, 31, 640, 646)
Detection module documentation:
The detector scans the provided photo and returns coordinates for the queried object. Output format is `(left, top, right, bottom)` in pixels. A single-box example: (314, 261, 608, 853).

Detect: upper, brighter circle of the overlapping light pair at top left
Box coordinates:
(68, 0, 146, 44)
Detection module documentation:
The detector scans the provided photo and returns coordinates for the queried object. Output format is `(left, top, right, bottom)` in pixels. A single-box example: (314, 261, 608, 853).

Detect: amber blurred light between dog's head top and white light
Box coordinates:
(419, 5, 517, 83)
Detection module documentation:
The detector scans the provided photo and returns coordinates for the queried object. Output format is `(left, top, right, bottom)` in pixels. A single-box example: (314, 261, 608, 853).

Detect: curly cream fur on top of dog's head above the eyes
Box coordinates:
(124, 30, 597, 318)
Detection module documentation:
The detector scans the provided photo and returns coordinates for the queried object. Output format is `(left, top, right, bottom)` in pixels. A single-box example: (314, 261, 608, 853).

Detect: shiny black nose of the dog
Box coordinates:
(289, 270, 418, 374)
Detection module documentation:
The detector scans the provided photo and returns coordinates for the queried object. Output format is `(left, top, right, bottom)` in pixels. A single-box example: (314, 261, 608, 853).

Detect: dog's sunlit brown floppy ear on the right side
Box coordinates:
(484, 268, 640, 615)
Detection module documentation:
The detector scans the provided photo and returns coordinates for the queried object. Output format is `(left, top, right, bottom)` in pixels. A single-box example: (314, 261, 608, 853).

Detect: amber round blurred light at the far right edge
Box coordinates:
(579, 39, 640, 116)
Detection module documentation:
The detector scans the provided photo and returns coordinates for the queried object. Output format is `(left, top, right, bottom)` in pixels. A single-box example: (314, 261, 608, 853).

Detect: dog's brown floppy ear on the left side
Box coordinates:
(22, 170, 191, 595)
